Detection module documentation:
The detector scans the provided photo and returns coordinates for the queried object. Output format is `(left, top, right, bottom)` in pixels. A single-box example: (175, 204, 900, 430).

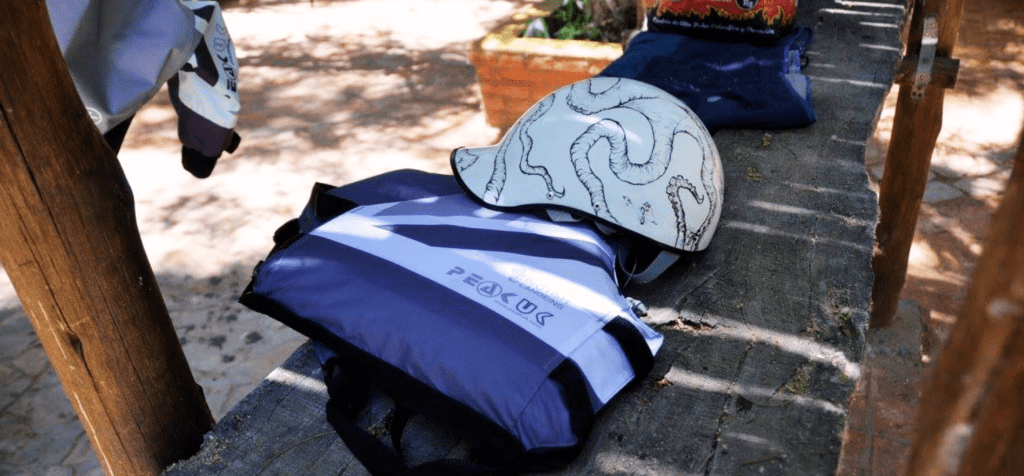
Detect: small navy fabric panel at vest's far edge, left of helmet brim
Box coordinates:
(330, 169, 463, 205)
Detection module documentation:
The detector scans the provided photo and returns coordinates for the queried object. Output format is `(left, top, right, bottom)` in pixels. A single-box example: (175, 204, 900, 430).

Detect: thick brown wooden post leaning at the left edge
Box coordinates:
(0, 0, 213, 475)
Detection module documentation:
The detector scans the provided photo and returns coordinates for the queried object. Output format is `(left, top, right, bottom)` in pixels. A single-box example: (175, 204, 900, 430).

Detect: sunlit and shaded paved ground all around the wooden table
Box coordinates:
(0, 0, 1024, 475)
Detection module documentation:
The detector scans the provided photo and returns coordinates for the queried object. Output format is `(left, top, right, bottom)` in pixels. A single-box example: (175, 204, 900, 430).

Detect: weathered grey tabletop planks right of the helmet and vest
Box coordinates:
(163, 0, 905, 476)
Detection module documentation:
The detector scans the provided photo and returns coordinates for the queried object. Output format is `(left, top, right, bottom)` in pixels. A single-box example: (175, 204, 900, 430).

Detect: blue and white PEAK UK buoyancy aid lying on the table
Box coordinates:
(242, 171, 663, 464)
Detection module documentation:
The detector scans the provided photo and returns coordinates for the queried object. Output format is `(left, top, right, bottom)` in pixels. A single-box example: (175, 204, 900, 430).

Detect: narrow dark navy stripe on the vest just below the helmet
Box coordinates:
(388, 225, 613, 276)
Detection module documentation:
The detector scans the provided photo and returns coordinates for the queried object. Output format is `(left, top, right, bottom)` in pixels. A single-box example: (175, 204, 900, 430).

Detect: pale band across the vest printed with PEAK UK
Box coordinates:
(310, 197, 625, 355)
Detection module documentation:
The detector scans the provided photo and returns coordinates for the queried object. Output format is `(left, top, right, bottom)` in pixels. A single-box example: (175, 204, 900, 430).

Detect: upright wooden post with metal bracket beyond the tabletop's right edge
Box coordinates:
(871, 0, 964, 328)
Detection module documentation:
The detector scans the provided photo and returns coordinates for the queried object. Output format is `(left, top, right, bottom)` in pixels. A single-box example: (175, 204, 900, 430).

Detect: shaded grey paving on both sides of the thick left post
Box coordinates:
(0, 257, 306, 475)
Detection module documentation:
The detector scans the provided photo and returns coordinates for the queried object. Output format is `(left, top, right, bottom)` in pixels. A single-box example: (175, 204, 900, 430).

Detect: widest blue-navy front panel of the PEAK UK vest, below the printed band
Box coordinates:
(253, 235, 572, 438)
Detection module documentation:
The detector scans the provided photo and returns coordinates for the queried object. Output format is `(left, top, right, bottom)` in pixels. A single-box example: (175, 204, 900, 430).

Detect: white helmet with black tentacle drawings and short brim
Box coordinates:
(452, 77, 723, 280)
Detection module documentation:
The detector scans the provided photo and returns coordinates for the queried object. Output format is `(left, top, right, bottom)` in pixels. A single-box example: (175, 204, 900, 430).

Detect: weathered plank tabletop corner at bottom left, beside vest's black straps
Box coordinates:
(164, 344, 460, 476)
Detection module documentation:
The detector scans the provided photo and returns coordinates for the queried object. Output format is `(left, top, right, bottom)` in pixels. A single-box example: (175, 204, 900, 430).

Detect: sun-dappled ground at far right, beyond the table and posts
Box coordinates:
(876, 0, 1024, 353)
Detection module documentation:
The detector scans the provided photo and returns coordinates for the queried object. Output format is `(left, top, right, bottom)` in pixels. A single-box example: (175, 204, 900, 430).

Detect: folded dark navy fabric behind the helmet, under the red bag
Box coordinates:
(599, 28, 815, 132)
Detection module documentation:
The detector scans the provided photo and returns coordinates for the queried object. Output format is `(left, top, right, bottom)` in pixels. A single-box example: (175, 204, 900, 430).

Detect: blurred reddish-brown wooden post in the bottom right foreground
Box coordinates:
(907, 128, 1024, 476)
